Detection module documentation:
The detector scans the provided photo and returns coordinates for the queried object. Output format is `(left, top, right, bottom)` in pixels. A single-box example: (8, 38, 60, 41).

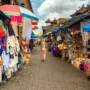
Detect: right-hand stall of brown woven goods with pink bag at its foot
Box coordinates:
(62, 28, 88, 75)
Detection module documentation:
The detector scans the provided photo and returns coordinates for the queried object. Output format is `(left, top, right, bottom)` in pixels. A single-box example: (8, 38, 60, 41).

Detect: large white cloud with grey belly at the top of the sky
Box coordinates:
(38, 0, 88, 16)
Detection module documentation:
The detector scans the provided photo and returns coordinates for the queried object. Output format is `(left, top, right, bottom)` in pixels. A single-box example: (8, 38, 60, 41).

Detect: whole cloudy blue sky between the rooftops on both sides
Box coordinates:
(31, 0, 90, 33)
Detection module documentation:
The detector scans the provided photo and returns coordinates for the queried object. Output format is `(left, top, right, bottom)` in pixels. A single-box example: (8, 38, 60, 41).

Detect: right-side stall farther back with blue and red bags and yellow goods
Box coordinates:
(52, 28, 67, 57)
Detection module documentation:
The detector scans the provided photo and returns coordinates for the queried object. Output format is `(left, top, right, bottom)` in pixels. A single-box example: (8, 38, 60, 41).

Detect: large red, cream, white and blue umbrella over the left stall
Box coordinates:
(0, 5, 38, 21)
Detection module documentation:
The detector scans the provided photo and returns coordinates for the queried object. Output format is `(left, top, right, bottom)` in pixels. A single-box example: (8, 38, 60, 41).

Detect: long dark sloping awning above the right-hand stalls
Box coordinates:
(61, 14, 90, 29)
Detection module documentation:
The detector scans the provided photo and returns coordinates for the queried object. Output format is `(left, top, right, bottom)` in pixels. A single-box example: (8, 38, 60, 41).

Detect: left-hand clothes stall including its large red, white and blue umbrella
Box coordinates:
(0, 5, 38, 83)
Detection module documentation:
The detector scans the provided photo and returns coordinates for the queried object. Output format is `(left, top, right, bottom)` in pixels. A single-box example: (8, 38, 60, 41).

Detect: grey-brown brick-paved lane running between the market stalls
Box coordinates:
(0, 46, 90, 90)
